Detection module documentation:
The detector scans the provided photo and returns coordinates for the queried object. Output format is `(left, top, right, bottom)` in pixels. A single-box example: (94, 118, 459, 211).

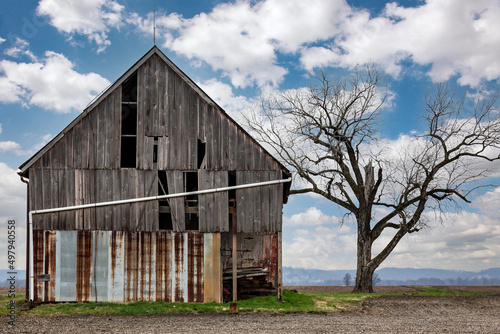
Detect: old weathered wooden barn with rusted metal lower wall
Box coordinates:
(19, 46, 290, 302)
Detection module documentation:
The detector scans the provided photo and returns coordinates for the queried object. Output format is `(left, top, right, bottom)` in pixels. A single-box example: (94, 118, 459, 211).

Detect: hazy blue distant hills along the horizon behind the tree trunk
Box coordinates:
(283, 267, 500, 286)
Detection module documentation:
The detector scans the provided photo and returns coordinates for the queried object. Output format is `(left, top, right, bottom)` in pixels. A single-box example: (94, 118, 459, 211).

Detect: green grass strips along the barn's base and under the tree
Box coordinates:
(0, 286, 487, 316)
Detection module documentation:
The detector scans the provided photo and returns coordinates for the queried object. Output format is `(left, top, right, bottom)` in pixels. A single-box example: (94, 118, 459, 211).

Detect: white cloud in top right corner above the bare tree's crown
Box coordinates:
(301, 0, 500, 86)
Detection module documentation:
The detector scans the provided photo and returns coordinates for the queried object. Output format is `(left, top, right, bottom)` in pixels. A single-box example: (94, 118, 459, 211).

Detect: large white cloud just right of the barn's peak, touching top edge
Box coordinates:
(129, 0, 350, 87)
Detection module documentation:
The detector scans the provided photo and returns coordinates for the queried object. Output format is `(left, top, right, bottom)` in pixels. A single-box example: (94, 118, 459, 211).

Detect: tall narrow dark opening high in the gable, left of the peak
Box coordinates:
(120, 73, 137, 168)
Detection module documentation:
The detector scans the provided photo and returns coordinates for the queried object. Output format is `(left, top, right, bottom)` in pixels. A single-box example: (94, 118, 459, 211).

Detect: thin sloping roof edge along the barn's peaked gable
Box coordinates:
(18, 45, 290, 178)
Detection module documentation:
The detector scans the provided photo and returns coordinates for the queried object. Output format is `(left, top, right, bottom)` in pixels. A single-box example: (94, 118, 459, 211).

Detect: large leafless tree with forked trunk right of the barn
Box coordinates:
(245, 67, 500, 292)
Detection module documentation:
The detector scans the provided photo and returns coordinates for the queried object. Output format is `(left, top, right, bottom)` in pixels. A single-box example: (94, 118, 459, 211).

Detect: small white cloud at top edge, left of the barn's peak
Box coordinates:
(37, 0, 124, 53)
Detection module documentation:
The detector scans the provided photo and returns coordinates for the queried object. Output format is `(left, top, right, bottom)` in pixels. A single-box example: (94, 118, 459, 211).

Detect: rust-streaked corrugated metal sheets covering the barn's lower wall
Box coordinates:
(34, 230, 221, 302)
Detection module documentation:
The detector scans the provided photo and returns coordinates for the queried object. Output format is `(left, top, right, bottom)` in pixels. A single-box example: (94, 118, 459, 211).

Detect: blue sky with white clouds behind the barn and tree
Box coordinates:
(0, 0, 500, 270)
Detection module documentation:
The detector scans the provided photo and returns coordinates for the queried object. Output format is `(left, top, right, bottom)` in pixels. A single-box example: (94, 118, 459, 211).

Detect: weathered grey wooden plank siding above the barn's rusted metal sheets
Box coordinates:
(29, 55, 283, 233)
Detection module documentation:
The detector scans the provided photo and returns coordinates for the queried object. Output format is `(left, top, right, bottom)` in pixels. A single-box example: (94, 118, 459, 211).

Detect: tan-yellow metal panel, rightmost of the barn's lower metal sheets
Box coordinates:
(203, 233, 222, 303)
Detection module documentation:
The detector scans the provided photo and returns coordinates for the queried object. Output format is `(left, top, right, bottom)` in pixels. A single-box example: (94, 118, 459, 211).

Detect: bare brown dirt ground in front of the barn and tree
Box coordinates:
(0, 287, 500, 333)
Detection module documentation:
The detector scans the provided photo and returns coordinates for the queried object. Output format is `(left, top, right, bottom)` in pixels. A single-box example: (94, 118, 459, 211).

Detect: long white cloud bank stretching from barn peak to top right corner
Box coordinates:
(127, 0, 500, 87)
